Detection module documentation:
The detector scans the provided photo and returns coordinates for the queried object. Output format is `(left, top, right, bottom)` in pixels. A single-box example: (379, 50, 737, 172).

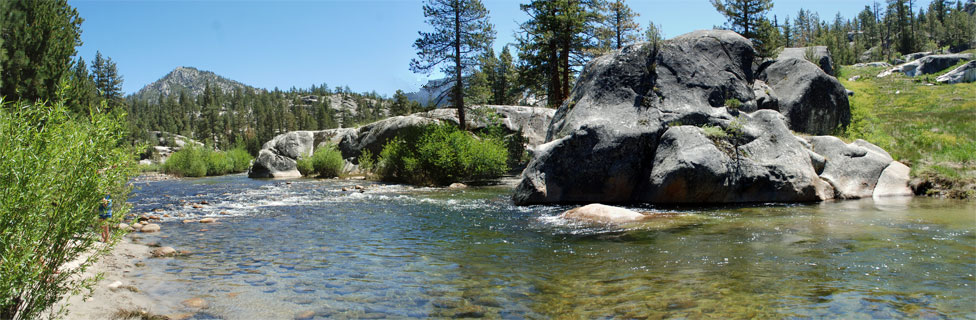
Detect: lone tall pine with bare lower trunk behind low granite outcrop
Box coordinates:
(410, 0, 495, 130)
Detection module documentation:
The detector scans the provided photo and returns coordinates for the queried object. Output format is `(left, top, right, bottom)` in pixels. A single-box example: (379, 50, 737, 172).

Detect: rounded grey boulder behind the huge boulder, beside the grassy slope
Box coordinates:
(759, 58, 851, 134)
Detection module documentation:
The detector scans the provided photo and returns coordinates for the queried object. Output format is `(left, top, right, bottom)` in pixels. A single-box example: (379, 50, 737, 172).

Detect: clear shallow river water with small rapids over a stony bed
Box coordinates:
(130, 175, 976, 319)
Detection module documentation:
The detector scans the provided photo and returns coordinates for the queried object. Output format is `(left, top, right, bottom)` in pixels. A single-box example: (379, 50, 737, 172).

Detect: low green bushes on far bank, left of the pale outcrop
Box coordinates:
(163, 145, 254, 177)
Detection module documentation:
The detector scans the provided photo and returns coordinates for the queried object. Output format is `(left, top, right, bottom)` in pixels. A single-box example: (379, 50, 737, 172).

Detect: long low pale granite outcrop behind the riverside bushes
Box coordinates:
(248, 106, 555, 178)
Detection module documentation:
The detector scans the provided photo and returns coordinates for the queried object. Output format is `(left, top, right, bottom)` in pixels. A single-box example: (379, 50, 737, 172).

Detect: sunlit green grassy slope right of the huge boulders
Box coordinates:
(838, 64, 976, 197)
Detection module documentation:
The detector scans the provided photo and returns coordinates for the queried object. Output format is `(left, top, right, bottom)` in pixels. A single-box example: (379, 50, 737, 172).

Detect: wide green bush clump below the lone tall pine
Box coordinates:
(377, 124, 509, 185)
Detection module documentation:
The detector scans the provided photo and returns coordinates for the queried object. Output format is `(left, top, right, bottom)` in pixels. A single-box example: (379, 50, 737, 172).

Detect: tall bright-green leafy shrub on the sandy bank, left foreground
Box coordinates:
(0, 101, 135, 319)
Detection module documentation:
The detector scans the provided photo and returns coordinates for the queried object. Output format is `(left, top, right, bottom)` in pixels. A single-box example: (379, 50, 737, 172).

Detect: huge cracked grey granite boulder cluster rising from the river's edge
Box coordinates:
(513, 30, 907, 205)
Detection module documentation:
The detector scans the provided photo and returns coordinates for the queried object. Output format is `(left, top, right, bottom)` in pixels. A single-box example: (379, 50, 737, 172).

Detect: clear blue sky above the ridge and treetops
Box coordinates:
(68, 0, 928, 96)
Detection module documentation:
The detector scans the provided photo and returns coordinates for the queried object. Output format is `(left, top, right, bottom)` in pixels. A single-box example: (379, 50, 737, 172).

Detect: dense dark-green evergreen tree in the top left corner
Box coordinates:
(0, 0, 83, 101)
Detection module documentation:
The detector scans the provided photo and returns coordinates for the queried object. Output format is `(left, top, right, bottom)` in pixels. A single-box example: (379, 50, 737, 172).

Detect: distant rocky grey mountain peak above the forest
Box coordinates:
(130, 67, 254, 102)
